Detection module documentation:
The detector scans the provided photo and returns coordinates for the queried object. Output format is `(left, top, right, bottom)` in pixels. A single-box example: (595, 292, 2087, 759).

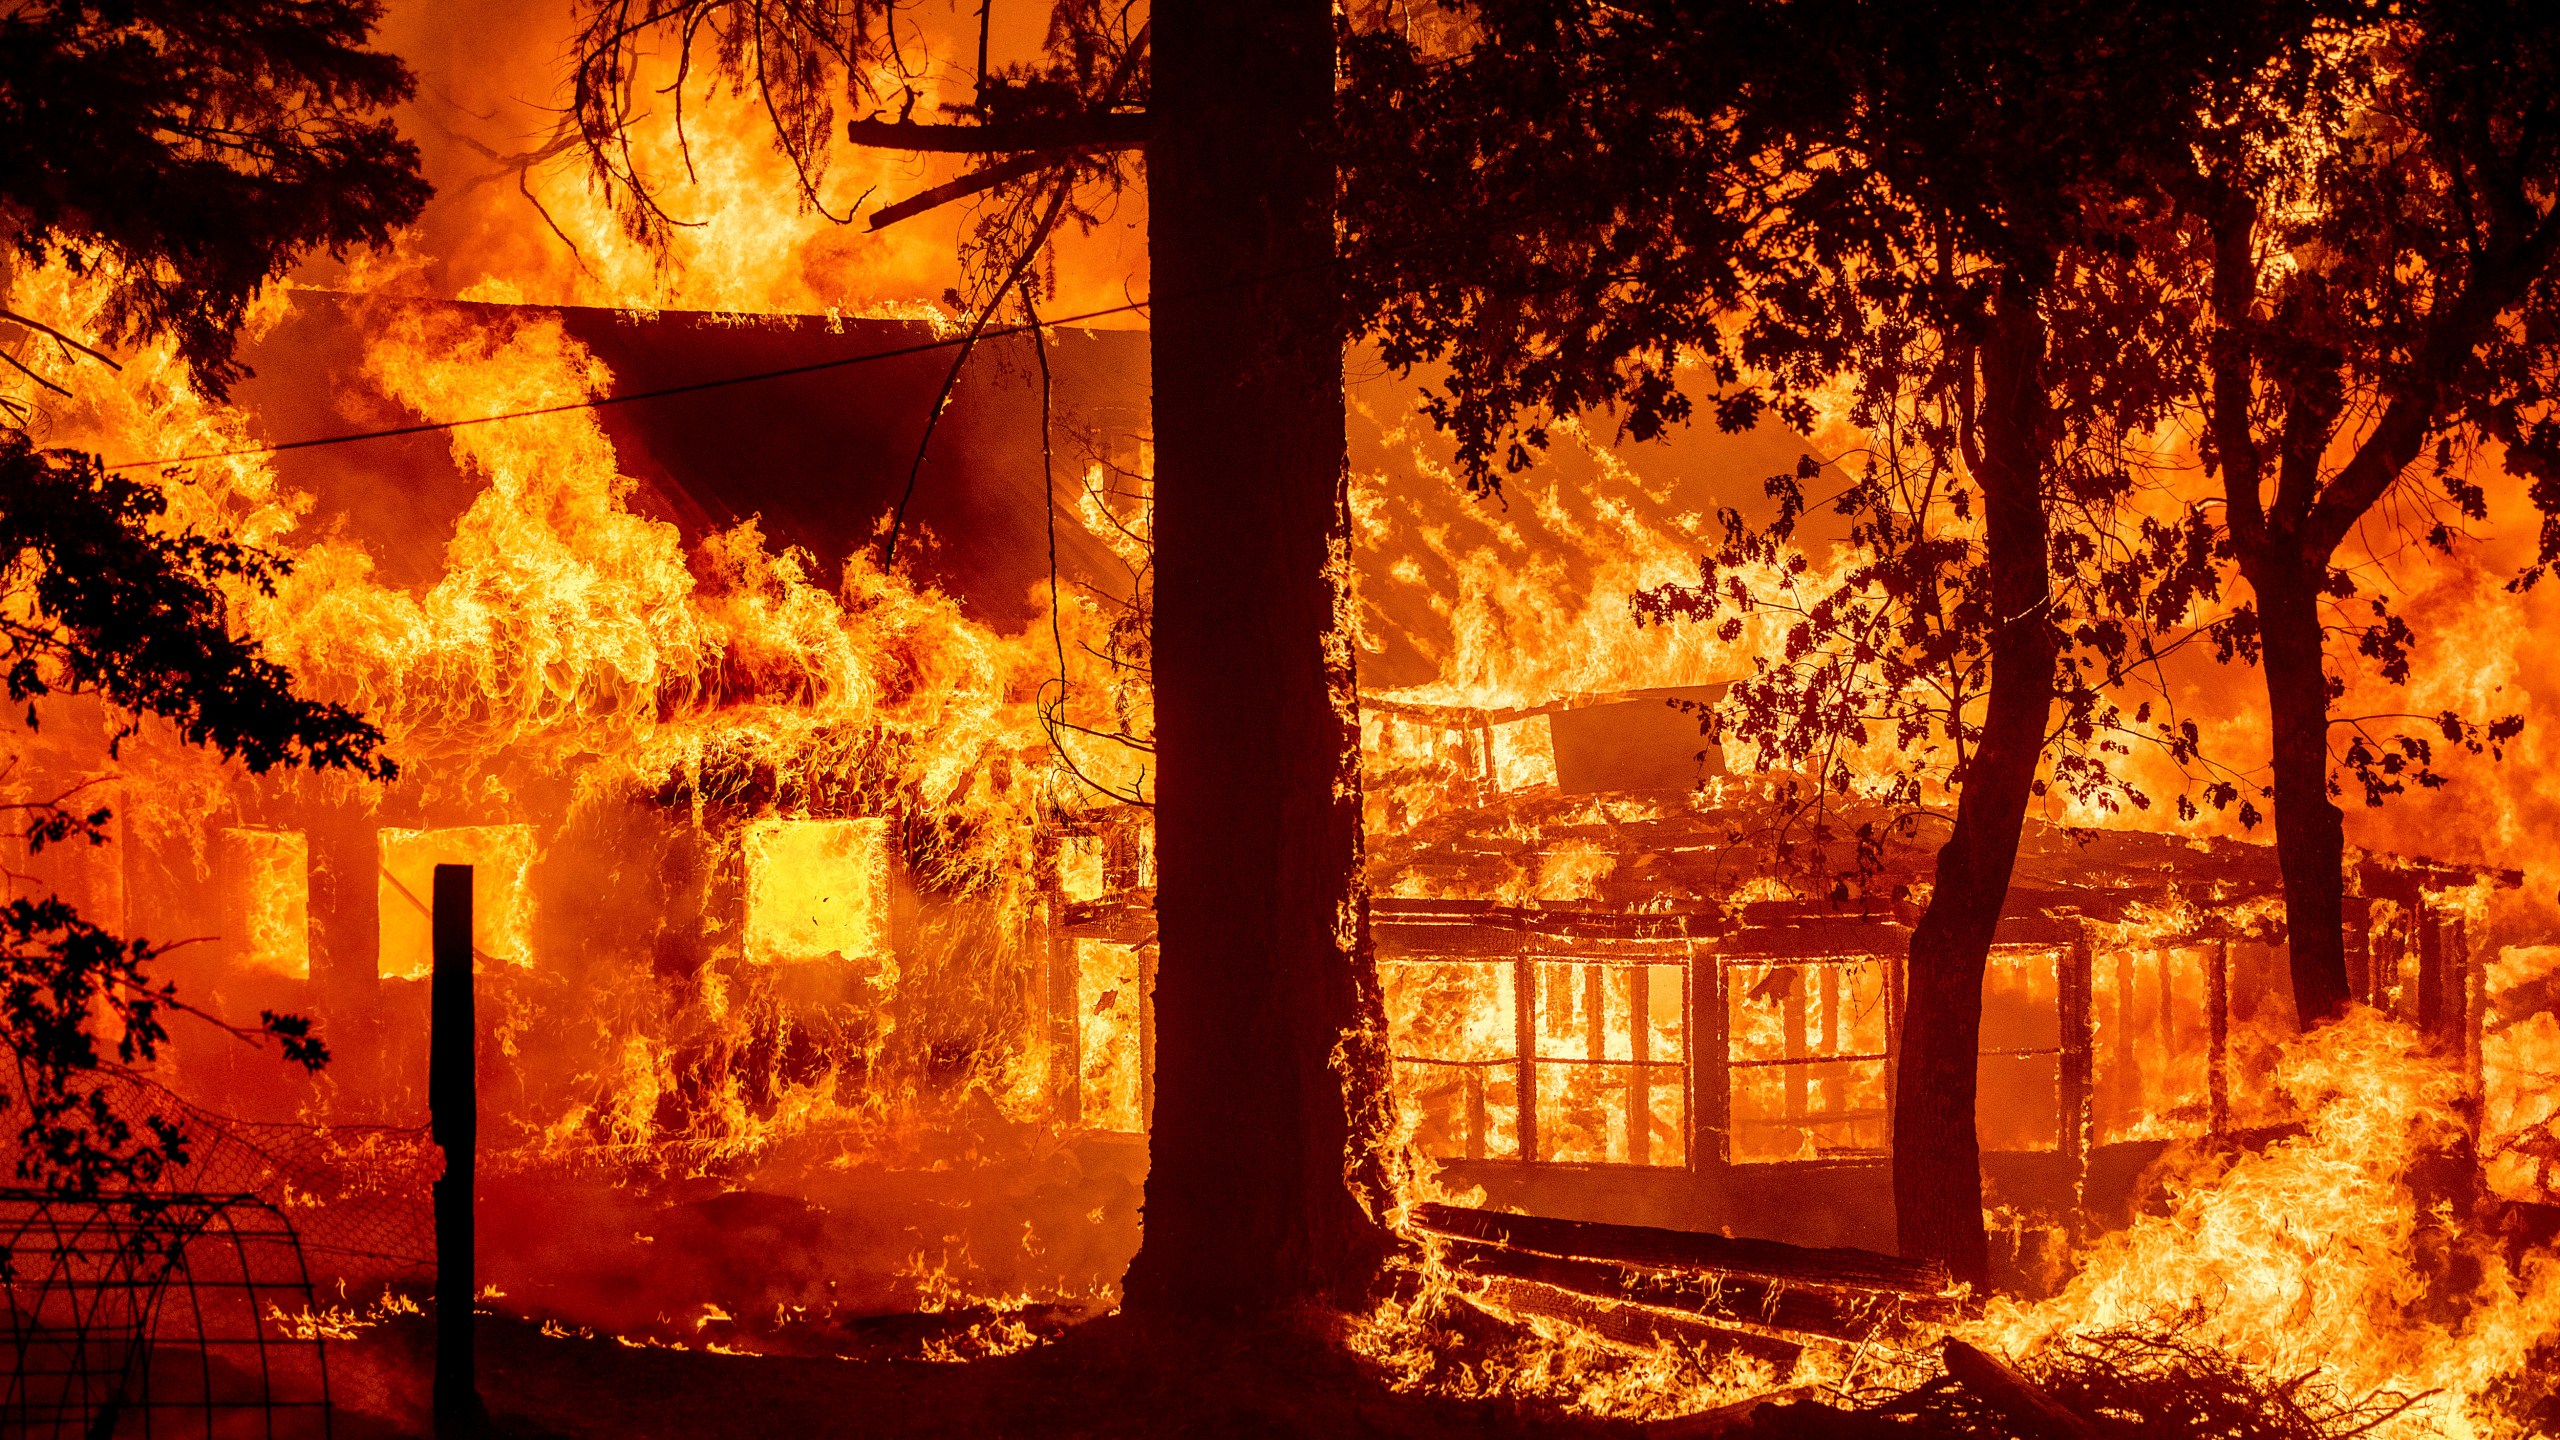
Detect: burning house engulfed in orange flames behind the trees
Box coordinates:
(15, 280, 2516, 1289)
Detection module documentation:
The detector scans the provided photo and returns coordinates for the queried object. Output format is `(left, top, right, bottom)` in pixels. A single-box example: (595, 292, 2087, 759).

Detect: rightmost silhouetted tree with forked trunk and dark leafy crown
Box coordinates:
(2148, 0, 2560, 1020)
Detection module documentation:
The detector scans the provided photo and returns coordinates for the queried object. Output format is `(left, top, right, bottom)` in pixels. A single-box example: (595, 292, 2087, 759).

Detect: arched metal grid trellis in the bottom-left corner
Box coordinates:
(0, 1191, 330, 1440)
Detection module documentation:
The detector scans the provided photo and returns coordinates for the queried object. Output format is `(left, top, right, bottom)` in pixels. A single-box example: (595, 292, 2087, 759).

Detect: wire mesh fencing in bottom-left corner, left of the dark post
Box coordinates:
(0, 1076, 443, 1440)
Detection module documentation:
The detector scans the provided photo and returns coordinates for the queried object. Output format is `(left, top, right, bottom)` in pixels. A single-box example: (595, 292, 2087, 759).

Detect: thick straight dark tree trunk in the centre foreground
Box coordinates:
(1126, 0, 1385, 1314)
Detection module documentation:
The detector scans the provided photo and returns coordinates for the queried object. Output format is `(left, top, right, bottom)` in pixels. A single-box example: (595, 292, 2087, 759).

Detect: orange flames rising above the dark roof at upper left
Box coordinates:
(373, 0, 1147, 320)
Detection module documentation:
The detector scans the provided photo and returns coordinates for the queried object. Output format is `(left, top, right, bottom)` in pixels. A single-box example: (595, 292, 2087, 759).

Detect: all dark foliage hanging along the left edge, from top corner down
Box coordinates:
(0, 0, 428, 1194)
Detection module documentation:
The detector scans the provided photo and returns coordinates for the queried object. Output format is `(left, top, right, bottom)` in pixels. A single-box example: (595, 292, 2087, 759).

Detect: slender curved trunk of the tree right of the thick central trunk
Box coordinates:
(1894, 282, 2058, 1284)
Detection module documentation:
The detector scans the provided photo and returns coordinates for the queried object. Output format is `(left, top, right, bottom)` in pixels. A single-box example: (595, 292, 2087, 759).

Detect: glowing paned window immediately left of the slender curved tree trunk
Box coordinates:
(1725, 956, 1889, 1163)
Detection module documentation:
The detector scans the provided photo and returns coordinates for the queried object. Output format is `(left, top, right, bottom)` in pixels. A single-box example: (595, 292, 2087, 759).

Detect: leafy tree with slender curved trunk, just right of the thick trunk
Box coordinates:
(1344, 0, 2319, 1279)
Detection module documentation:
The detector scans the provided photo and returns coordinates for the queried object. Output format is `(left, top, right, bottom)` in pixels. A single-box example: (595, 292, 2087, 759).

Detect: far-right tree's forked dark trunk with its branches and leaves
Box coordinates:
(2191, 16, 2560, 1027)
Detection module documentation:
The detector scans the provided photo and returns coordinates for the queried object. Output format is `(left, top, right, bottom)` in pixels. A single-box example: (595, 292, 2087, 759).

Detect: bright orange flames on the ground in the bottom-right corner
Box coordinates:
(1979, 1010, 2560, 1437)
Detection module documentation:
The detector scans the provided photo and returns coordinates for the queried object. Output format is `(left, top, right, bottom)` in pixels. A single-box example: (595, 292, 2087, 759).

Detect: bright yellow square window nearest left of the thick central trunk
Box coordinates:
(745, 817, 893, 979)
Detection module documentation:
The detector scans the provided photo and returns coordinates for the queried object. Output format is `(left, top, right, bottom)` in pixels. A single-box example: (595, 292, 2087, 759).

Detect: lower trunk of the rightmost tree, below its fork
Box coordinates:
(2248, 541, 2348, 1030)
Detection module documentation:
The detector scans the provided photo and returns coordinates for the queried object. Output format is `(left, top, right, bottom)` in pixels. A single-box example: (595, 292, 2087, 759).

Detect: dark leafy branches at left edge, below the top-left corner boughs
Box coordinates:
(0, 440, 394, 1194)
